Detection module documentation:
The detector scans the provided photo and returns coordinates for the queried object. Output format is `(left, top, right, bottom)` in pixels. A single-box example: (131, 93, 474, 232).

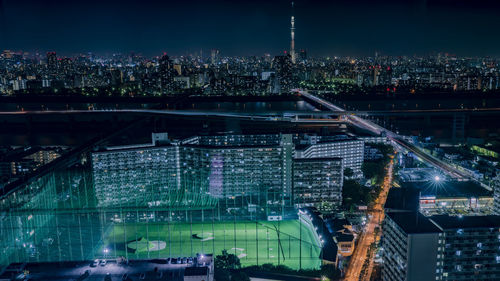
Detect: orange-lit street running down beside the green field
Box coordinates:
(344, 160, 394, 281)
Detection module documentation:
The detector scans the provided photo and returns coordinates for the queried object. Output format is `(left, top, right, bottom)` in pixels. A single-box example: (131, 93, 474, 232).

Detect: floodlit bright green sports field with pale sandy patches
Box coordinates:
(99, 220, 321, 269)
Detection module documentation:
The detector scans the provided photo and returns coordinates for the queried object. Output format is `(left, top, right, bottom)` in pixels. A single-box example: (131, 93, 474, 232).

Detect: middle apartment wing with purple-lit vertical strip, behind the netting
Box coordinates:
(180, 145, 291, 198)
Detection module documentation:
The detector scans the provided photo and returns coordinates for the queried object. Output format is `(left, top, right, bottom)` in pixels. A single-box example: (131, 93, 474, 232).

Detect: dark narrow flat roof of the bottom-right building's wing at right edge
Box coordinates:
(430, 215, 500, 229)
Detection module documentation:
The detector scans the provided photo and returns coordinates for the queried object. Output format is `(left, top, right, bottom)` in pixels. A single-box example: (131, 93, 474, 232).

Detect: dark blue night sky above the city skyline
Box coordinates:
(0, 0, 500, 56)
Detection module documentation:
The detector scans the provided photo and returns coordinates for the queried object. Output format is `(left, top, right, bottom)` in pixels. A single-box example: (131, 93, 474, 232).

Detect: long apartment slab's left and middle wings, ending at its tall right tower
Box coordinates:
(92, 134, 293, 212)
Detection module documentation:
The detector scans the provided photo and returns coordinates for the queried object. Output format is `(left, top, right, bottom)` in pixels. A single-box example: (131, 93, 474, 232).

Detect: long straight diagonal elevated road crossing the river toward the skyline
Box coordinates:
(298, 90, 470, 180)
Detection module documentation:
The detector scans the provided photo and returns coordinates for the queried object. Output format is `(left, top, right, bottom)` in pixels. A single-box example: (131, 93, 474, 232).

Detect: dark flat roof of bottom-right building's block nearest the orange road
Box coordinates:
(386, 212, 441, 234)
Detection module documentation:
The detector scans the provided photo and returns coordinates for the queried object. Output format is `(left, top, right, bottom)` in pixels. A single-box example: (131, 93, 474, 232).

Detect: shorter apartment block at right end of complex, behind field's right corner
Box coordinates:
(293, 158, 344, 210)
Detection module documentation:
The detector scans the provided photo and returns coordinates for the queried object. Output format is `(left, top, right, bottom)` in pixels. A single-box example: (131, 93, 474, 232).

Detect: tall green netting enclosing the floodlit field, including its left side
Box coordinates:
(0, 168, 321, 268)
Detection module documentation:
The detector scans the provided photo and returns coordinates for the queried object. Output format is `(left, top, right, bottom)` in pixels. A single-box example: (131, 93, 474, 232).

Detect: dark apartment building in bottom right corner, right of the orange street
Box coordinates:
(382, 212, 500, 281)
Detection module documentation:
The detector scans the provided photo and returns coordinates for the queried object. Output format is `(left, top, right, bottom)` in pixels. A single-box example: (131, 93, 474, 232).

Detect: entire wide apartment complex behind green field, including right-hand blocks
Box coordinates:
(92, 134, 354, 209)
